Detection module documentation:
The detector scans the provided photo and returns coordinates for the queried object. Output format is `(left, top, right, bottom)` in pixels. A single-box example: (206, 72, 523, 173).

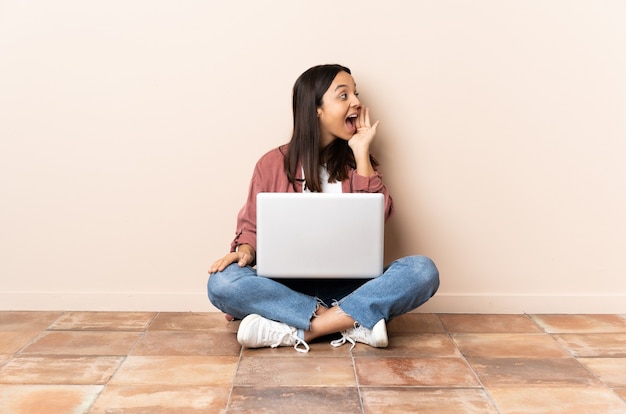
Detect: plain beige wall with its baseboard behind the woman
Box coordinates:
(0, 0, 626, 313)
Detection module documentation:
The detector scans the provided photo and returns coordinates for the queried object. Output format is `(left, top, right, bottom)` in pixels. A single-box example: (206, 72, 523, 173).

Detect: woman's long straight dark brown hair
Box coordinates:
(284, 64, 378, 192)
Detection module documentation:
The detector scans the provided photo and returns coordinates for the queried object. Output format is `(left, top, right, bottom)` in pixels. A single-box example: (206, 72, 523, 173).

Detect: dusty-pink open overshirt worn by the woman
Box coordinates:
(230, 145, 393, 252)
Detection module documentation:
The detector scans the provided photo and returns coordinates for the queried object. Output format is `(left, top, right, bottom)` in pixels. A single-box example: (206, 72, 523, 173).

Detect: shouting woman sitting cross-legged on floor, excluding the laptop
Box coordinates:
(208, 65, 439, 352)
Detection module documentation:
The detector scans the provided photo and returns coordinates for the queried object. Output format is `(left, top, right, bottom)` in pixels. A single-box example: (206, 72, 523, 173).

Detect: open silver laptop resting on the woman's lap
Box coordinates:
(256, 193, 385, 278)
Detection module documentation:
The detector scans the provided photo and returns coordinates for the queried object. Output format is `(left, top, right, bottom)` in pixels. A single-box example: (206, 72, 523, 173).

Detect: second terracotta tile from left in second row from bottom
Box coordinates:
(110, 356, 238, 387)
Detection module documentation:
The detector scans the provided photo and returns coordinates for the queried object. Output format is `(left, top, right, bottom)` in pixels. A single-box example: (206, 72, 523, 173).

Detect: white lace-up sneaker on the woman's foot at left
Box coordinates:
(237, 313, 310, 352)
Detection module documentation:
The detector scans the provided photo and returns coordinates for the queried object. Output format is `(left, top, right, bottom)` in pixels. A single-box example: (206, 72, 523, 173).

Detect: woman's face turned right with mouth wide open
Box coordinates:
(317, 72, 361, 148)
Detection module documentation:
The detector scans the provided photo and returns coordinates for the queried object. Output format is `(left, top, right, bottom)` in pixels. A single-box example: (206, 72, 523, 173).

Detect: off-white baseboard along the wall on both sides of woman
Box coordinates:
(0, 292, 626, 314)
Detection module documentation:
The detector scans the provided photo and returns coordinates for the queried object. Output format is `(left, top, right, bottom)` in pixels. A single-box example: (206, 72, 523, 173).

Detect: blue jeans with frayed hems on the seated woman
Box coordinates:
(207, 256, 439, 330)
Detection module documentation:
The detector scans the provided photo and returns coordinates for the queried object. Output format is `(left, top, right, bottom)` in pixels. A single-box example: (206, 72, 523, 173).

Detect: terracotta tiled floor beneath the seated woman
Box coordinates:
(0, 312, 626, 414)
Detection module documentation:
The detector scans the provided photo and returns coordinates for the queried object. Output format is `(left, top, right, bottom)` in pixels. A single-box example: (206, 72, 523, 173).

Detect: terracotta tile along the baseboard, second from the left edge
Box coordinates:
(48, 312, 156, 331)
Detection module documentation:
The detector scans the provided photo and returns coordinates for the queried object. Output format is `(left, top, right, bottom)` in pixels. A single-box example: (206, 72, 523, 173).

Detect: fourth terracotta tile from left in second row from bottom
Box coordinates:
(355, 357, 479, 387)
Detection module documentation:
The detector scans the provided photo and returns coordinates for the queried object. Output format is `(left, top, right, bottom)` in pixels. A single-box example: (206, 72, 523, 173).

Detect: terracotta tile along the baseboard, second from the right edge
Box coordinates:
(438, 313, 543, 333)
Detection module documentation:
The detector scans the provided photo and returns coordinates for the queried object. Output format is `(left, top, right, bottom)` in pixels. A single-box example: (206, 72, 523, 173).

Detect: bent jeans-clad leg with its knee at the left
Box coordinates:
(207, 263, 317, 330)
